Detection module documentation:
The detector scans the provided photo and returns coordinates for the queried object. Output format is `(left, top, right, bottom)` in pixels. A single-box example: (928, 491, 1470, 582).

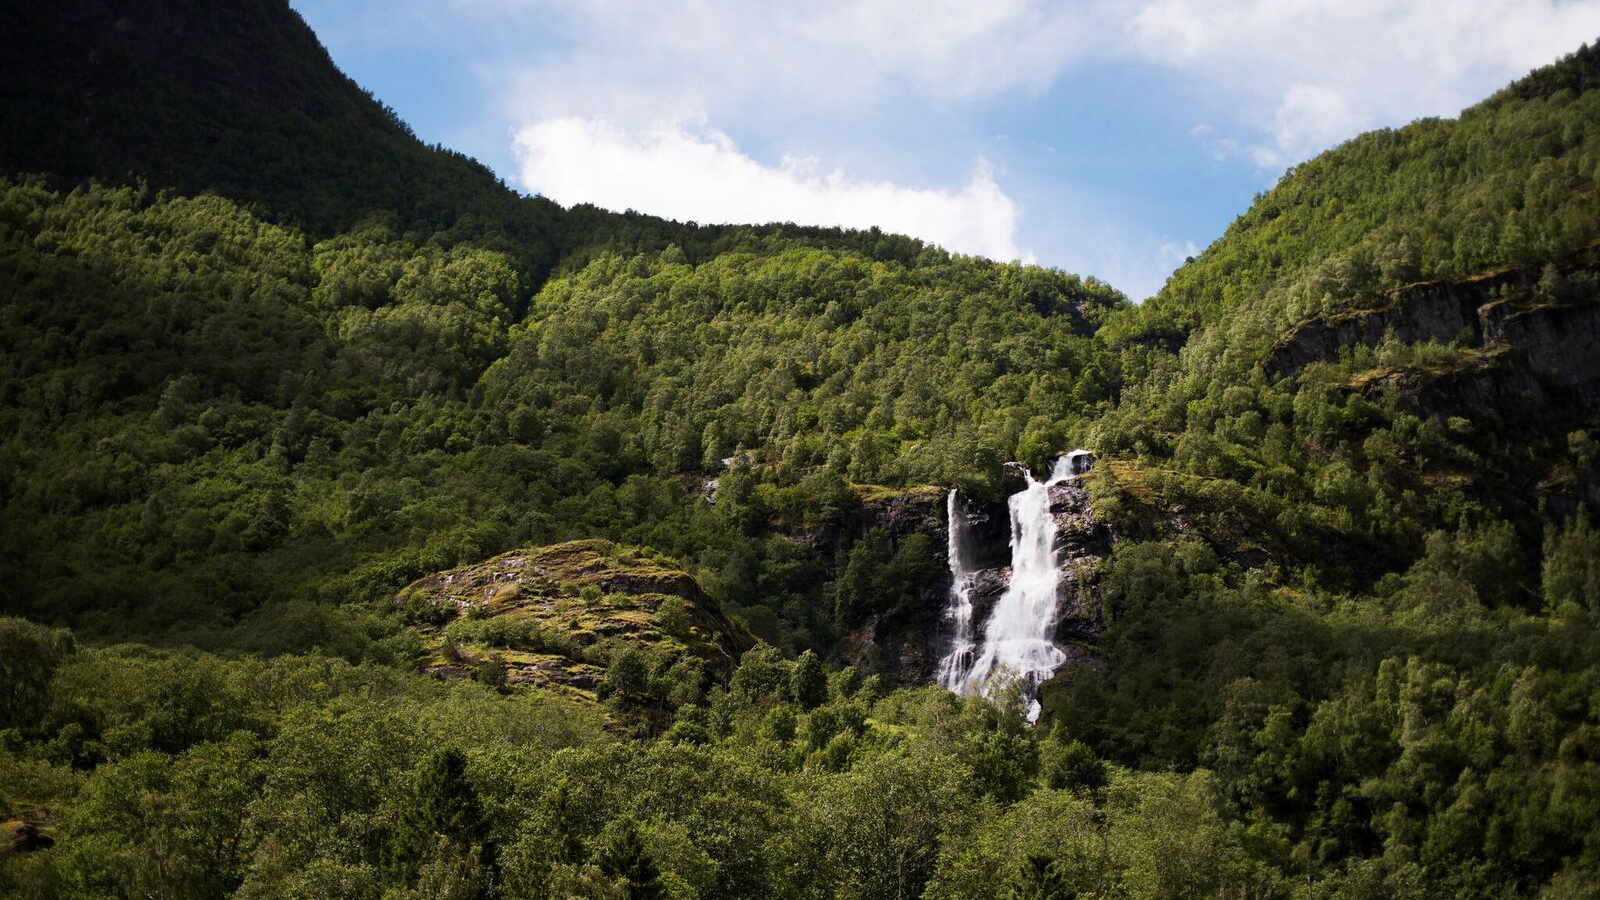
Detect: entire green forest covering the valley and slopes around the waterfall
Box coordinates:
(0, 0, 1600, 900)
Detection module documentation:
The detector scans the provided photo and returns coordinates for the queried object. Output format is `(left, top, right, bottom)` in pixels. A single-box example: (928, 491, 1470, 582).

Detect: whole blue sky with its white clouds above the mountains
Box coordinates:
(291, 0, 1600, 299)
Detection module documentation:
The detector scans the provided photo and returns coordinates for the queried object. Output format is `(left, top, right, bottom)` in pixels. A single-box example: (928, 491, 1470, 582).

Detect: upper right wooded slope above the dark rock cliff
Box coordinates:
(1114, 45, 1600, 344)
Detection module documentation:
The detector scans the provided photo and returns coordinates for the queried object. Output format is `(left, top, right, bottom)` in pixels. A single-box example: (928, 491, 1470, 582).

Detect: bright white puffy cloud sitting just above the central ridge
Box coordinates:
(515, 117, 1024, 259)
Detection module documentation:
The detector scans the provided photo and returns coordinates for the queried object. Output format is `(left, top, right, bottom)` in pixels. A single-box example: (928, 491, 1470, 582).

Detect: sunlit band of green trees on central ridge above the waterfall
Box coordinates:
(485, 250, 1122, 490)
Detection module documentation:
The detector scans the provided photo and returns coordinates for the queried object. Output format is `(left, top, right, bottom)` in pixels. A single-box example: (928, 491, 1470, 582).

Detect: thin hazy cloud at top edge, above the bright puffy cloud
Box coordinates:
(480, 0, 1091, 120)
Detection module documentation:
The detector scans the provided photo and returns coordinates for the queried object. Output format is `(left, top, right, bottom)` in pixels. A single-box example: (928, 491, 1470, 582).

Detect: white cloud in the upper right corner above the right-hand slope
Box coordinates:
(1123, 0, 1600, 168)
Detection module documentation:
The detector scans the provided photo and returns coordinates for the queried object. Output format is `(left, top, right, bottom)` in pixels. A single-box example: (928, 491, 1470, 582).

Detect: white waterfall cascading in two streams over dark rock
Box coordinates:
(939, 450, 1091, 721)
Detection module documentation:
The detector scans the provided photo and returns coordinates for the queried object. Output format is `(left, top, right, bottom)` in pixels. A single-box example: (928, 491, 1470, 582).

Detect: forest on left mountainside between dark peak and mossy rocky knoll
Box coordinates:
(0, 168, 1123, 650)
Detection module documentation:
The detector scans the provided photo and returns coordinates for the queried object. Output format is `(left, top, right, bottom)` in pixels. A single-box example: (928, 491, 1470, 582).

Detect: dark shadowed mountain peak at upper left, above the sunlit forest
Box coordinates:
(0, 0, 558, 243)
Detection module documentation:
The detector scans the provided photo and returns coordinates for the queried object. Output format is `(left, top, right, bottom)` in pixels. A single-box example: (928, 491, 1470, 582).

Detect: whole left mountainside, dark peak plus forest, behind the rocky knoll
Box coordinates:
(0, 0, 1126, 647)
